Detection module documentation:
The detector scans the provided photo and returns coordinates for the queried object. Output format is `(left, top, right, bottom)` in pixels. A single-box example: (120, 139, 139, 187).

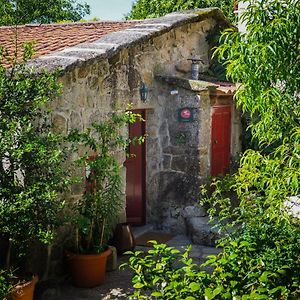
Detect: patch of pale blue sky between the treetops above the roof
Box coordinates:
(84, 0, 134, 20)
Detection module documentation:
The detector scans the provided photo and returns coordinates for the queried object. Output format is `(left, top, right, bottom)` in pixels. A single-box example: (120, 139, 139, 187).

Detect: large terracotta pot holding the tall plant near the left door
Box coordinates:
(67, 248, 111, 288)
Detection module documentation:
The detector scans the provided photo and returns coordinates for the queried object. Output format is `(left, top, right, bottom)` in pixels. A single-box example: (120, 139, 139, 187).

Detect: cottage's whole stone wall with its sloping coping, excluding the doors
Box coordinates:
(25, 9, 237, 268)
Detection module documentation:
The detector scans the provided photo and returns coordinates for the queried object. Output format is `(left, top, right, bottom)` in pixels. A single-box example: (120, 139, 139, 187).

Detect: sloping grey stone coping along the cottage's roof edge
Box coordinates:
(28, 7, 232, 72)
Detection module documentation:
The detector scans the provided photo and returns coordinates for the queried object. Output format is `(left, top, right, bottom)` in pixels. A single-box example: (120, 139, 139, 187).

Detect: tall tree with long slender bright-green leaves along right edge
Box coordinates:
(212, 0, 300, 222)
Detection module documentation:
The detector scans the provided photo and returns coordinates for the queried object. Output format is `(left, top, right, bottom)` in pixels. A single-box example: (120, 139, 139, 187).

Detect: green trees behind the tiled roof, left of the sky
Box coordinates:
(0, 0, 90, 25)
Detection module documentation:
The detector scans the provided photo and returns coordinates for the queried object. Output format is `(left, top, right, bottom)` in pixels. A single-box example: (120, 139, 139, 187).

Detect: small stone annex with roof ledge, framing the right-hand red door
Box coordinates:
(147, 76, 240, 233)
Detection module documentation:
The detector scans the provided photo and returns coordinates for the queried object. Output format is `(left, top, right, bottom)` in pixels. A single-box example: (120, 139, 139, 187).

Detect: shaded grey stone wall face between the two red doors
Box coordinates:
(147, 84, 202, 232)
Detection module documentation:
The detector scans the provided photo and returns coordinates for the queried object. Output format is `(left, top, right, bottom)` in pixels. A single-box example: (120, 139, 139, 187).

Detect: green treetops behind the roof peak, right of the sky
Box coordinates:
(127, 0, 235, 21)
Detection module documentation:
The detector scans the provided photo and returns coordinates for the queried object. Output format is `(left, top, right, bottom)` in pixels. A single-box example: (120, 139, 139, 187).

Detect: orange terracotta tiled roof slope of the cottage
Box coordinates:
(0, 21, 137, 65)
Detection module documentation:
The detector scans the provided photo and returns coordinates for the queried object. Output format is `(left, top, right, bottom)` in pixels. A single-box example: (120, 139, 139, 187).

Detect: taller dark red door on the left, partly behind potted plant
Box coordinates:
(125, 110, 146, 225)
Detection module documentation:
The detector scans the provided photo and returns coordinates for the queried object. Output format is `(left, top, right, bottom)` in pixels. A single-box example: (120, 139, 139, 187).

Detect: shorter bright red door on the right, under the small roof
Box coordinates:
(211, 106, 231, 176)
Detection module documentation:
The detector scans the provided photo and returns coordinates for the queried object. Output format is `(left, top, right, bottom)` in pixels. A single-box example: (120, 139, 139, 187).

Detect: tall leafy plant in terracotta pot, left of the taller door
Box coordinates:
(67, 110, 141, 287)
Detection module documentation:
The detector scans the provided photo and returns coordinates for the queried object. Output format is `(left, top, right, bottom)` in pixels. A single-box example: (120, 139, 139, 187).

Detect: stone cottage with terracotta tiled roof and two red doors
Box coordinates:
(0, 8, 240, 233)
